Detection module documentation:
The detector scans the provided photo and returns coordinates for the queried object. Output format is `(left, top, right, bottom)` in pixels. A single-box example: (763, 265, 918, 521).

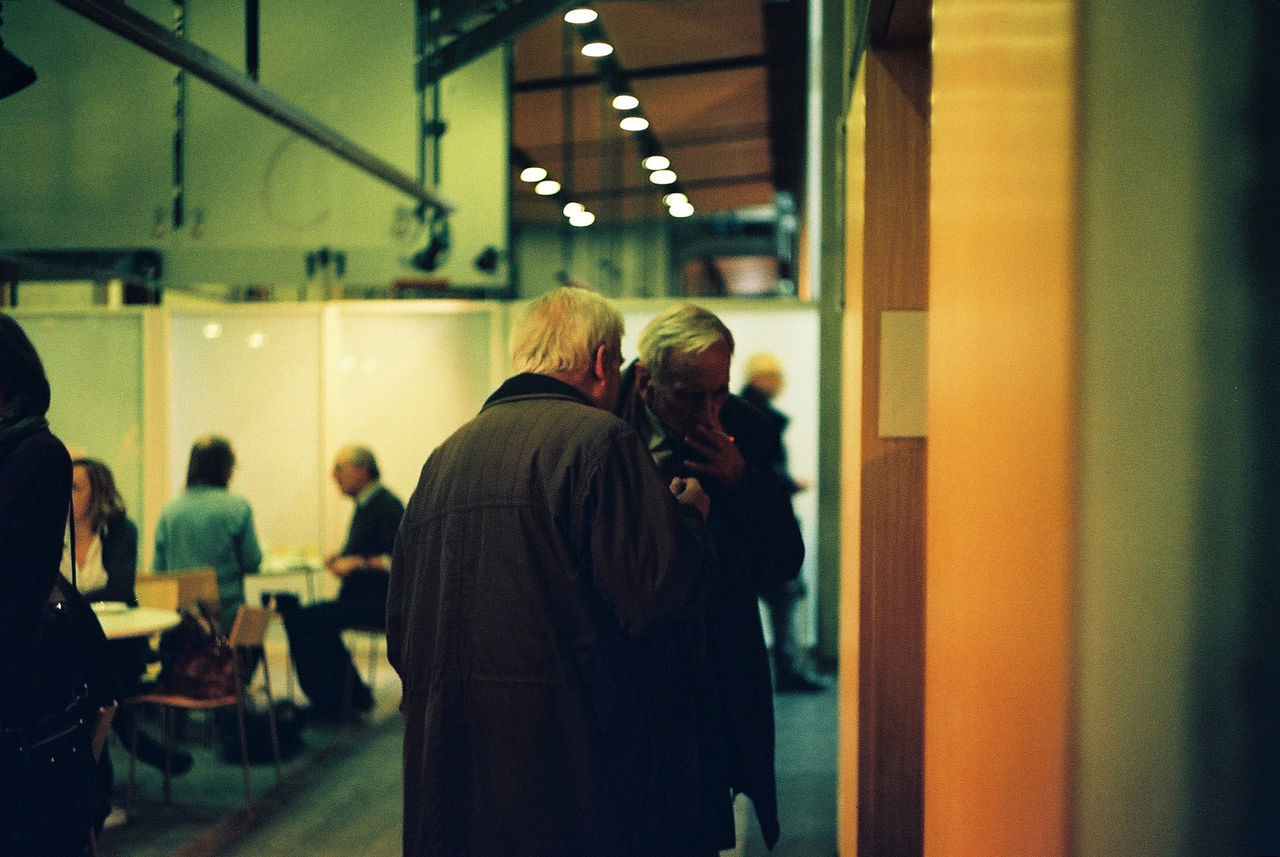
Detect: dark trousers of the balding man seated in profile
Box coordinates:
(282, 572, 388, 716)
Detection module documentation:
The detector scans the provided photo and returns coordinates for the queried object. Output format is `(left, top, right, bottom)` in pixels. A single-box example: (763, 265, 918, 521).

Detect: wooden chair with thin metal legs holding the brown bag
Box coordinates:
(124, 606, 280, 817)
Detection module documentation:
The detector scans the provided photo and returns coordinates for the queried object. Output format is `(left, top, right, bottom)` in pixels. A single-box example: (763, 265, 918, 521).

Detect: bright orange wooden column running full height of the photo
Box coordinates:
(924, 0, 1078, 857)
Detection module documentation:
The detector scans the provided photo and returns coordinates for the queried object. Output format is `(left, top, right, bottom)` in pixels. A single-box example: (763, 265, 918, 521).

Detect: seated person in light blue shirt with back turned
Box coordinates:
(151, 435, 262, 634)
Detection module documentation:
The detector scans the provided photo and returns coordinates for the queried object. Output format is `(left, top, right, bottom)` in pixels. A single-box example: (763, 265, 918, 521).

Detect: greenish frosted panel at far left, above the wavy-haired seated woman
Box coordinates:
(13, 311, 143, 526)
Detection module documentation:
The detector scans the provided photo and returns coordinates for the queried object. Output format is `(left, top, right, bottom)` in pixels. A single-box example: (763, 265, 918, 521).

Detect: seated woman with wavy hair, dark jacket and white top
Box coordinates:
(63, 458, 192, 776)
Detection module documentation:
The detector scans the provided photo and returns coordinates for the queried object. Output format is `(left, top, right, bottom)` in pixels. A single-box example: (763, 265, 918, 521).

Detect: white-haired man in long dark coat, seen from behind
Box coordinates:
(387, 288, 714, 857)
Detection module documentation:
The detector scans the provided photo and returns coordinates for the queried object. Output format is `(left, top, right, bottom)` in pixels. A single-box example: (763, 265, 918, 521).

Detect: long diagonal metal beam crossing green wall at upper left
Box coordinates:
(56, 0, 454, 212)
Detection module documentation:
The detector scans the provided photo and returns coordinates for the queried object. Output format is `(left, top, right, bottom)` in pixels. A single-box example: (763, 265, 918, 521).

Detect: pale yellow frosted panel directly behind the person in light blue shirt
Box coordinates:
(169, 307, 329, 553)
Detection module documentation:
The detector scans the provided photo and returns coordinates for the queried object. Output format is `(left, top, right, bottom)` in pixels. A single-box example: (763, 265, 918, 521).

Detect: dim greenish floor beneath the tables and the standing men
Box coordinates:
(99, 626, 836, 857)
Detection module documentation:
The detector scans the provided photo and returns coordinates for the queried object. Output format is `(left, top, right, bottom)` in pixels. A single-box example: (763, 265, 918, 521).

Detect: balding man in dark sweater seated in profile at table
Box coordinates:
(276, 446, 404, 720)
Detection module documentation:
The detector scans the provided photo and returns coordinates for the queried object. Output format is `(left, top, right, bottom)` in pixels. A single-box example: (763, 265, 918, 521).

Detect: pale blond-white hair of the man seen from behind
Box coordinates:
(511, 287, 622, 375)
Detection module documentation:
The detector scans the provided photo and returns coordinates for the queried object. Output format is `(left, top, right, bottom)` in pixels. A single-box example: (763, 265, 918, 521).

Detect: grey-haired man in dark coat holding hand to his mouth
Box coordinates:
(618, 304, 804, 848)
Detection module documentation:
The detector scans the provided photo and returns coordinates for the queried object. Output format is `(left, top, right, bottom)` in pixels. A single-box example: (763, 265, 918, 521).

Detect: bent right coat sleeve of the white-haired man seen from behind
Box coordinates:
(577, 423, 716, 633)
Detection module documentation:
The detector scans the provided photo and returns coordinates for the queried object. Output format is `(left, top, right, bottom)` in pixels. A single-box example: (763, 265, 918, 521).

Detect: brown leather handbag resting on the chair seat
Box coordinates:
(159, 601, 236, 700)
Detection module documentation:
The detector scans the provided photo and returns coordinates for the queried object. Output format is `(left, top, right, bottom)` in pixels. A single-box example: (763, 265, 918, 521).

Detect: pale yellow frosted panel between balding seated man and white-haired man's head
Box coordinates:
(325, 303, 500, 547)
